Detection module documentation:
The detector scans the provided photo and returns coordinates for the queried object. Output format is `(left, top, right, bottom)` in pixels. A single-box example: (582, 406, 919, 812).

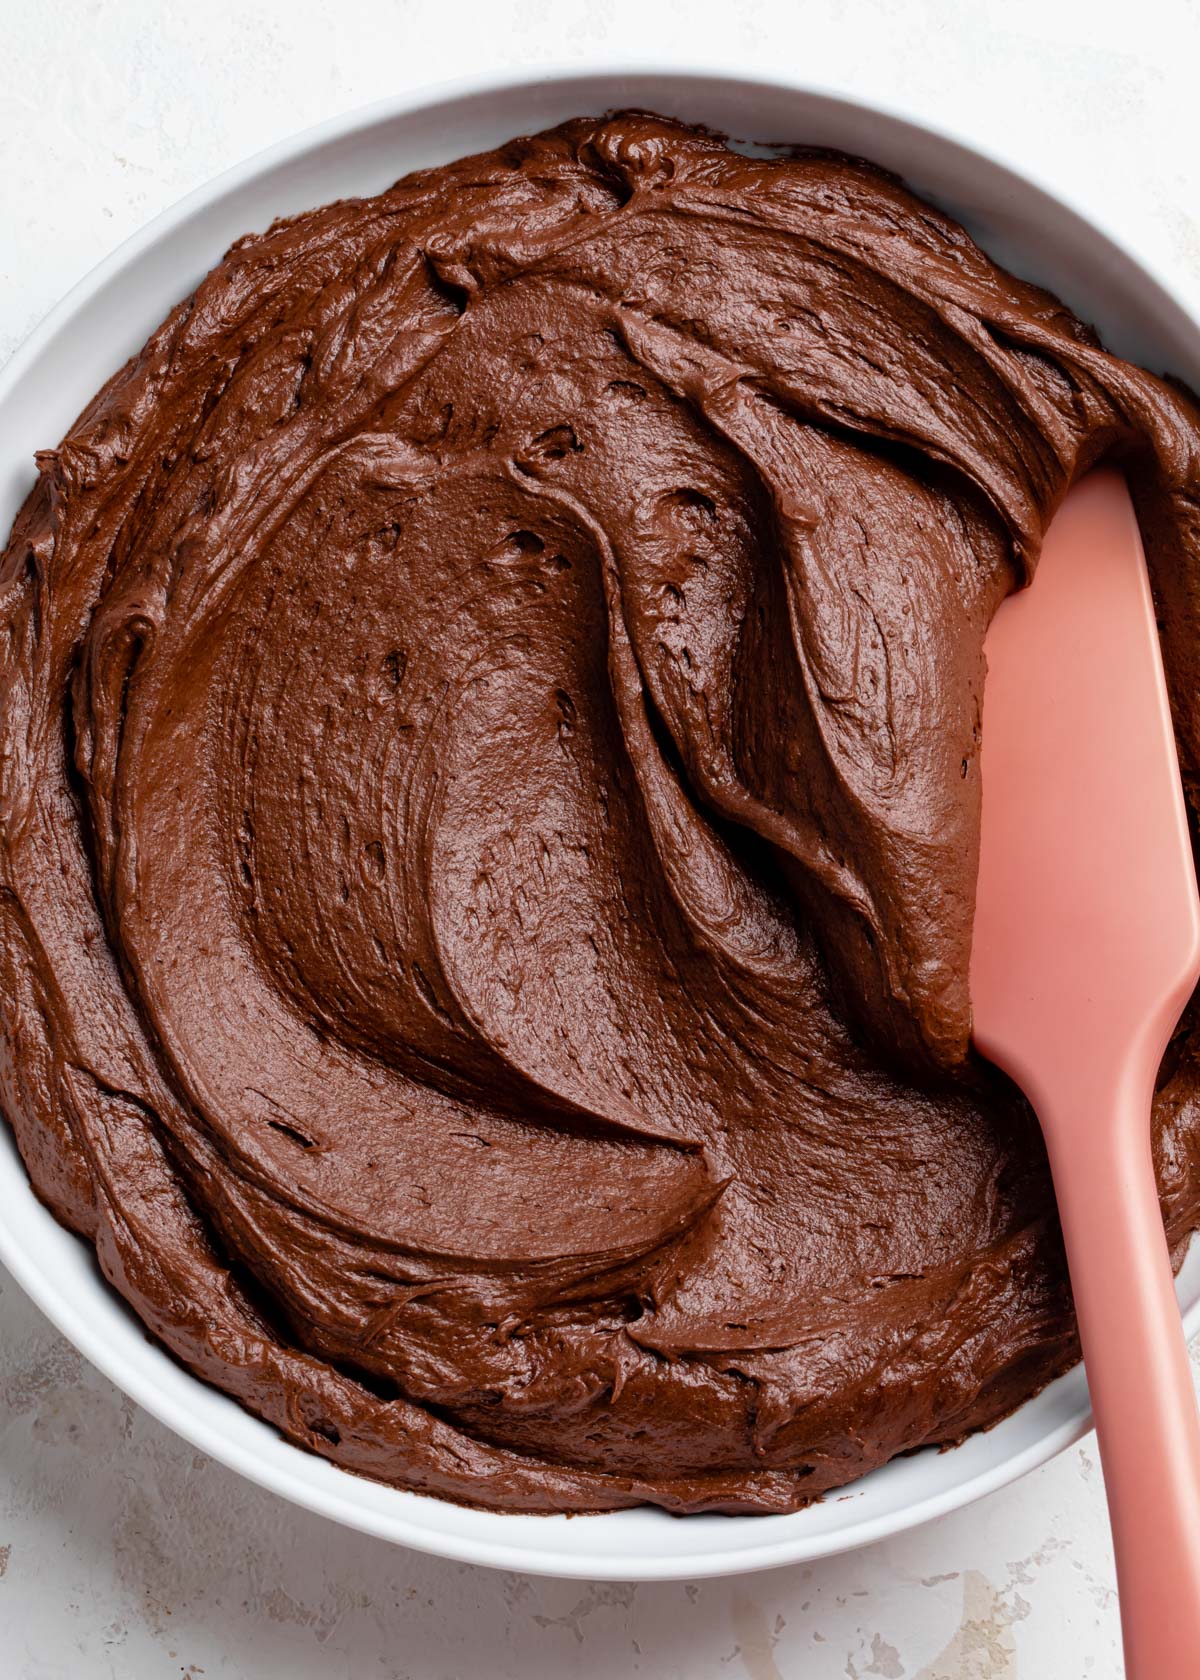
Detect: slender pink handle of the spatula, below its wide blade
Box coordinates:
(1044, 1085, 1200, 1680)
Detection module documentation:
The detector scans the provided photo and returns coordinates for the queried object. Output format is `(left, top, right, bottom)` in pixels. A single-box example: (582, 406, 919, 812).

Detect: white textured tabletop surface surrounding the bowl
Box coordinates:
(0, 0, 1200, 1680)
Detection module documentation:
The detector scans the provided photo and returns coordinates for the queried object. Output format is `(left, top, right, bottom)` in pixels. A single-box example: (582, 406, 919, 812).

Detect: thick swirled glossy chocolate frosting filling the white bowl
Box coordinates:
(0, 114, 1200, 1512)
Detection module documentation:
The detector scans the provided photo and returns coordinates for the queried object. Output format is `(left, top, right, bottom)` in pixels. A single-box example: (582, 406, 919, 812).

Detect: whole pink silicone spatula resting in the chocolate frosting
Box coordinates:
(970, 469, 1200, 1680)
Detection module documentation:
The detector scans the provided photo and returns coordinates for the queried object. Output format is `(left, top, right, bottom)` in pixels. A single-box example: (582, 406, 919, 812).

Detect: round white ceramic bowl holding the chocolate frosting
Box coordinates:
(0, 69, 1200, 1581)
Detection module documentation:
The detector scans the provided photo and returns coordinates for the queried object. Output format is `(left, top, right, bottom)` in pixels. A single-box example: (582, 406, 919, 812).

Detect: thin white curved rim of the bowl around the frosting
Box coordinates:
(0, 57, 1200, 1581)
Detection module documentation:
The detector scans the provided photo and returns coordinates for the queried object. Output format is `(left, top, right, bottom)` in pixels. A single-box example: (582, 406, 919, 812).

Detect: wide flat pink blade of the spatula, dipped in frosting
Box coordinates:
(970, 469, 1200, 1097)
